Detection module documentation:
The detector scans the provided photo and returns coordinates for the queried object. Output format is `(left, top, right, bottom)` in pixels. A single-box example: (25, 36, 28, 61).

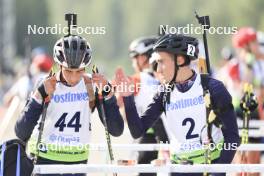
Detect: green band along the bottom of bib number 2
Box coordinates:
(170, 141, 223, 164)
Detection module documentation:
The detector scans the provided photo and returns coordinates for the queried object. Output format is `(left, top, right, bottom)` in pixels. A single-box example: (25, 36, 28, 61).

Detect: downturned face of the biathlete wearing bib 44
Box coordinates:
(61, 67, 85, 86)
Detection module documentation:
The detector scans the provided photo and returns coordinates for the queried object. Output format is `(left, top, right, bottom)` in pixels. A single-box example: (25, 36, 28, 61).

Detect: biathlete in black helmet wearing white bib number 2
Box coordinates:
(116, 34, 239, 176)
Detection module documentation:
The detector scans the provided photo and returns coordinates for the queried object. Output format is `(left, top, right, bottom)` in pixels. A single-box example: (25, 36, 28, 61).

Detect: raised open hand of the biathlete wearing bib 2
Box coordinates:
(115, 68, 134, 97)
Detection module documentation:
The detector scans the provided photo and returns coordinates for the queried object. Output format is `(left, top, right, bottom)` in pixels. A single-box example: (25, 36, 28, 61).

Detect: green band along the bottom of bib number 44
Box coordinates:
(28, 139, 89, 162)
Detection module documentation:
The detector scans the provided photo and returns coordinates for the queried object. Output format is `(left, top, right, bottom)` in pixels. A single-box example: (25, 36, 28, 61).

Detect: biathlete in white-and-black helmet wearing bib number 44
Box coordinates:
(15, 28, 124, 176)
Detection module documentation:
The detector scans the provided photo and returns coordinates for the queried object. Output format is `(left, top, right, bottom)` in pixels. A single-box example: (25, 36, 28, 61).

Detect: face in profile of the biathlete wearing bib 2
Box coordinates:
(155, 52, 175, 83)
